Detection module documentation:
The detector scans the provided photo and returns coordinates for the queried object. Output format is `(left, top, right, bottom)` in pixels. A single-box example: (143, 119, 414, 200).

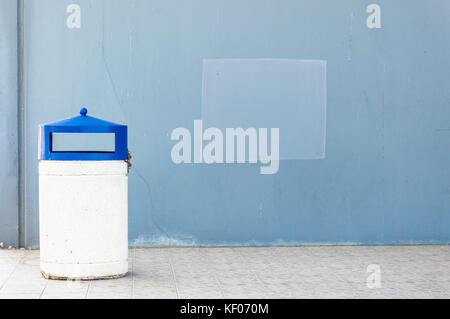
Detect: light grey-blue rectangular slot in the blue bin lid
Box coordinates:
(51, 132, 115, 153)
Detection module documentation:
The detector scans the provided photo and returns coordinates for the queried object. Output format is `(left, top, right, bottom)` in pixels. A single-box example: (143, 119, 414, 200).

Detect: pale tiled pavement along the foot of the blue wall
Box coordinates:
(0, 245, 450, 298)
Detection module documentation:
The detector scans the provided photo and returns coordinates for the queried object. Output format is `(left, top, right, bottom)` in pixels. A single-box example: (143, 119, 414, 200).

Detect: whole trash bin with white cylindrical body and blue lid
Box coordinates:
(39, 108, 128, 280)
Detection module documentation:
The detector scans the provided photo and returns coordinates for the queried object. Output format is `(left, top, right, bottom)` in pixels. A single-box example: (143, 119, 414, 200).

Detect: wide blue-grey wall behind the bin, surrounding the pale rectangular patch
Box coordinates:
(19, 0, 450, 247)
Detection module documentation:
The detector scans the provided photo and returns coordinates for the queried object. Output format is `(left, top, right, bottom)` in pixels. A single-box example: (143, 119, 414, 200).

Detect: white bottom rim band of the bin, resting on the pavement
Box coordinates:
(41, 261, 128, 280)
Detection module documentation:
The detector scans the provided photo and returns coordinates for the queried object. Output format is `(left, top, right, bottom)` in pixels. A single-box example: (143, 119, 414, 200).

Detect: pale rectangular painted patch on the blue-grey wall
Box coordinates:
(202, 59, 327, 160)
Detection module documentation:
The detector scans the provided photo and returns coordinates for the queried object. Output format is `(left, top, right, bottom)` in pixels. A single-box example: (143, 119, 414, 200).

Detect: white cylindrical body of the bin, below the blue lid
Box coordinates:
(39, 161, 128, 279)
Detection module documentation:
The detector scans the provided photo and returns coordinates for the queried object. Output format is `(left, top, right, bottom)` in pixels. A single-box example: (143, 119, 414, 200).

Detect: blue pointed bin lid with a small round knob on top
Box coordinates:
(39, 108, 128, 161)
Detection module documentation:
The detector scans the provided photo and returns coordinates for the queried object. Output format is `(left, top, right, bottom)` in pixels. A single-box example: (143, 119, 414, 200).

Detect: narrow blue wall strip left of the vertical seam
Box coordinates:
(0, 0, 19, 247)
